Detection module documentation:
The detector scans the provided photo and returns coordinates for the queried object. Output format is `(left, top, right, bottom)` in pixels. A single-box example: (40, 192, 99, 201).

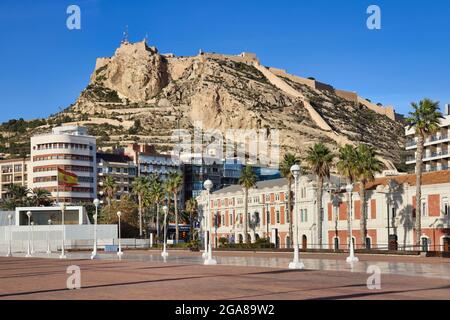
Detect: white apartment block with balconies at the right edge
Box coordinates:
(405, 104, 450, 172)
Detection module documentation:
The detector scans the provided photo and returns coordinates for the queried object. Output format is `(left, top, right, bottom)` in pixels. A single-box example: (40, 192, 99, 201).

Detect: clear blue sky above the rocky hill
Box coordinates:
(0, 0, 450, 121)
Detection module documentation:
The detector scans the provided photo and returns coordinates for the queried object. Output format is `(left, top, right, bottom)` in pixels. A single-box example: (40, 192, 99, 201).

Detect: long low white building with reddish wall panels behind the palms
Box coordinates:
(197, 170, 450, 251)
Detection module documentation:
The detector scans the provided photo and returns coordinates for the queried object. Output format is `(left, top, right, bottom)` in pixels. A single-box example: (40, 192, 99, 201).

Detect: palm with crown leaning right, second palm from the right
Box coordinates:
(355, 144, 384, 248)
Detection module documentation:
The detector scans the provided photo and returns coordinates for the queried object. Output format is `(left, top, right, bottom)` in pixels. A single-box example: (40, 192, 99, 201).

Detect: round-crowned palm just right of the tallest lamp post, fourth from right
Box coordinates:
(306, 143, 334, 249)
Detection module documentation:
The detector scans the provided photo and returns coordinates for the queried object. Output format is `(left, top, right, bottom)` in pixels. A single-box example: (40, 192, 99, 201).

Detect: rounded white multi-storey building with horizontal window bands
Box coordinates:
(29, 126, 97, 203)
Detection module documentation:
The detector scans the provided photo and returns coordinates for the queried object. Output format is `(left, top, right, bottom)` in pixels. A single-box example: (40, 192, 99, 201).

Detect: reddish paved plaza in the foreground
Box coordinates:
(0, 250, 450, 300)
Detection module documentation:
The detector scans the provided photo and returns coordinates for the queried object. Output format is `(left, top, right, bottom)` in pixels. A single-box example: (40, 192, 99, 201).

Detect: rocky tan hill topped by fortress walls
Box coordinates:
(0, 41, 404, 169)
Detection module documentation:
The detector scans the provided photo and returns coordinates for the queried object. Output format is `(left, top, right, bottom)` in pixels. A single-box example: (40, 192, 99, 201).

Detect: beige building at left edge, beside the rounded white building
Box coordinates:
(0, 159, 30, 199)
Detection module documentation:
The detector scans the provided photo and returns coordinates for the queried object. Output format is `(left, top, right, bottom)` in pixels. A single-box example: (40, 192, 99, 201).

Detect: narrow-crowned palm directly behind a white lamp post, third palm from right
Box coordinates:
(336, 144, 356, 250)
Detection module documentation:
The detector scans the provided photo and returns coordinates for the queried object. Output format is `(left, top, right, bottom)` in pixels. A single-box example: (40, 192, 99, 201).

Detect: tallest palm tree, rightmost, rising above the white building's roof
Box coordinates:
(406, 99, 443, 246)
